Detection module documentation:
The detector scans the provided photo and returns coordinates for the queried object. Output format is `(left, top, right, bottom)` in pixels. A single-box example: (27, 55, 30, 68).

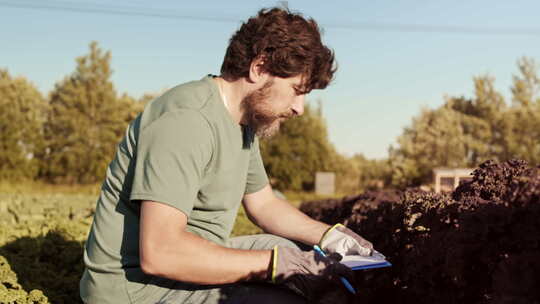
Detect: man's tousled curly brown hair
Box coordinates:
(221, 8, 337, 94)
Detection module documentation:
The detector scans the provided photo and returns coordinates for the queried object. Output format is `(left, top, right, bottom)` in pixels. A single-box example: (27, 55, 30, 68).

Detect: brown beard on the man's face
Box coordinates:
(241, 81, 292, 138)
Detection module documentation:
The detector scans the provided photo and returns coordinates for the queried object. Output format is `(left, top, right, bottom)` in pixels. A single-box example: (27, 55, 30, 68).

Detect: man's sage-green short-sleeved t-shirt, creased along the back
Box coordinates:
(80, 75, 268, 303)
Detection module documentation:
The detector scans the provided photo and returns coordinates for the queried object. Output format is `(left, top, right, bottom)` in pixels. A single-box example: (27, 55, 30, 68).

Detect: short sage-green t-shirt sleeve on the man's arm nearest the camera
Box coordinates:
(130, 110, 213, 217)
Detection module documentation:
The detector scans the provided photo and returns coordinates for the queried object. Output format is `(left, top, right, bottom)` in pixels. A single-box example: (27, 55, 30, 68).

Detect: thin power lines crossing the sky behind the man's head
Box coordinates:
(0, 0, 540, 36)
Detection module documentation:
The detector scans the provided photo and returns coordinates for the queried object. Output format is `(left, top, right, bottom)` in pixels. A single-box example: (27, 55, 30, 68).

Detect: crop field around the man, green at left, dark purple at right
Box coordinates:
(0, 160, 540, 304)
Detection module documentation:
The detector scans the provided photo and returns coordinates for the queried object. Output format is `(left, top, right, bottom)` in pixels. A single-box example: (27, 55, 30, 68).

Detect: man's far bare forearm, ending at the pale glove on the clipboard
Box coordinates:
(243, 185, 330, 245)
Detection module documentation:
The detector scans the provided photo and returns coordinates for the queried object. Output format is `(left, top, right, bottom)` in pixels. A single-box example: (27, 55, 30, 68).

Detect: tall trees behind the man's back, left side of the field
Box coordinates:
(0, 42, 150, 184)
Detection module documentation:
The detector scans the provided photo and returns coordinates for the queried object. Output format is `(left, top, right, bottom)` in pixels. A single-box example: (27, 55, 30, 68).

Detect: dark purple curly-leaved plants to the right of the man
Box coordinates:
(300, 160, 540, 304)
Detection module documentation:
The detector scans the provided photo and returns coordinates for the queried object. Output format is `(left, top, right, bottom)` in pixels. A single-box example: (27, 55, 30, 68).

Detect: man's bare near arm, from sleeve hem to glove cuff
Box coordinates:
(139, 201, 272, 285)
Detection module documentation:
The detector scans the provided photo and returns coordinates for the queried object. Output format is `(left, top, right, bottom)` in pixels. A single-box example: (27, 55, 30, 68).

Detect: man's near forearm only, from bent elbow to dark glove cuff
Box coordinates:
(141, 231, 272, 285)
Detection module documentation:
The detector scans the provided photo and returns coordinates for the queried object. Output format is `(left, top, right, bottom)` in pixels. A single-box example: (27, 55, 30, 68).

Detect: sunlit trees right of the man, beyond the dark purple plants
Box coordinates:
(262, 57, 540, 193)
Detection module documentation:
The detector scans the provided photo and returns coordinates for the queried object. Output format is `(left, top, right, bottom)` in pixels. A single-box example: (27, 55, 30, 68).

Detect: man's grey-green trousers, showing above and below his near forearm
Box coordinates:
(141, 234, 307, 304)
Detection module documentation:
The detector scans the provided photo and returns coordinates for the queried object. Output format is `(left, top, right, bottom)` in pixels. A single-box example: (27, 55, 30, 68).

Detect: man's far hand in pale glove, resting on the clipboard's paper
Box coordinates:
(319, 224, 373, 256)
